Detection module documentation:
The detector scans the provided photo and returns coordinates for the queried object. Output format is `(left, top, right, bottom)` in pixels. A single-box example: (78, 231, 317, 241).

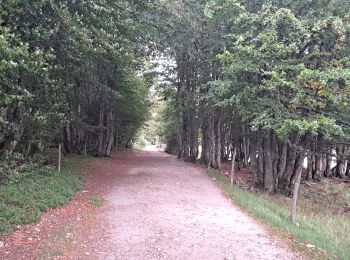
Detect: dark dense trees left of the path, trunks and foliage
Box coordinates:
(0, 1, 152, 159)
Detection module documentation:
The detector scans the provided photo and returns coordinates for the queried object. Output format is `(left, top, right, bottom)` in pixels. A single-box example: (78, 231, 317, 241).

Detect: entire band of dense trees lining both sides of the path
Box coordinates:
(0, 0, 350, 196)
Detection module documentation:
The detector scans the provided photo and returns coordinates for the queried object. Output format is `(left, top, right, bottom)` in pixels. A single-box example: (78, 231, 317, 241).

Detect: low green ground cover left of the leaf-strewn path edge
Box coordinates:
(0, 157, 82, 234)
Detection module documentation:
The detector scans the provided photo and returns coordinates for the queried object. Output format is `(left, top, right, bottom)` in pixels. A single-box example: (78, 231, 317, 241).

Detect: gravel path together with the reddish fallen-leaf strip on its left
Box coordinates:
(0, 151, 302, 259)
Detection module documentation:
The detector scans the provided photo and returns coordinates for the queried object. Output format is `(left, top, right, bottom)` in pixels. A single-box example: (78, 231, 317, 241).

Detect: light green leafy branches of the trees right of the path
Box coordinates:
(201, 1, 350, 145)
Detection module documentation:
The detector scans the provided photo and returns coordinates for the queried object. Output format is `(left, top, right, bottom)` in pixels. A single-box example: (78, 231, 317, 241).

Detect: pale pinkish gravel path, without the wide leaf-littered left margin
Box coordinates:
(67, 151, 300, 259)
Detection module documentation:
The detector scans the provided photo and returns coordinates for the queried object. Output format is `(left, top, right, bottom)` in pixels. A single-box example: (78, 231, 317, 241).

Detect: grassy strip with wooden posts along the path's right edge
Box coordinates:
(208, 171, 350, 259)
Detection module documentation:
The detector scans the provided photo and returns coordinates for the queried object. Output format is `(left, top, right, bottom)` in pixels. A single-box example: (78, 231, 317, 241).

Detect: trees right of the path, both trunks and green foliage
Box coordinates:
(154, 0, 350, 197)
